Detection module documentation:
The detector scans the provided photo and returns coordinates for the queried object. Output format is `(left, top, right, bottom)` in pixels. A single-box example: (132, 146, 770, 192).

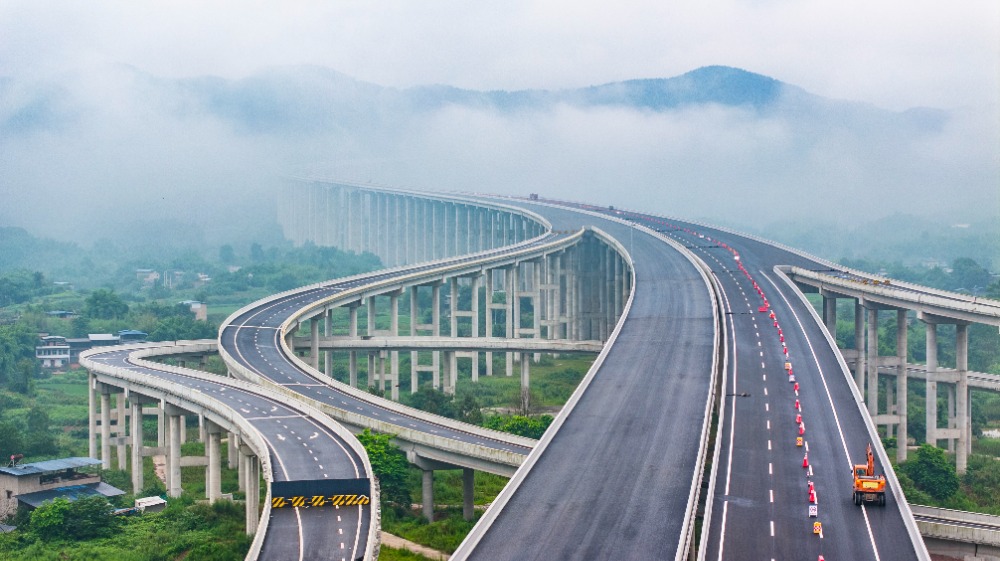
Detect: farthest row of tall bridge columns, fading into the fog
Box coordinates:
(279, 181, 543, 267)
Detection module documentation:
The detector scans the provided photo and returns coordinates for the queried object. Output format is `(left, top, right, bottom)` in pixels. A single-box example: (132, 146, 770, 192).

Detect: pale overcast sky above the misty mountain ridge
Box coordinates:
(0, 0, 1000, 109)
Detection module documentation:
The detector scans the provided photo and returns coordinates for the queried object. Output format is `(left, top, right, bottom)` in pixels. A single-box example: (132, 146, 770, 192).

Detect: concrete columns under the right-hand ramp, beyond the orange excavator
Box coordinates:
(823, 294, 972, 474)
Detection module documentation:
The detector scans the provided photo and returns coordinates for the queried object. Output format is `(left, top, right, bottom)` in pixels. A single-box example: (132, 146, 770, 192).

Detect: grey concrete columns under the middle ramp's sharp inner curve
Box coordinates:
(289, 231, 630, 400)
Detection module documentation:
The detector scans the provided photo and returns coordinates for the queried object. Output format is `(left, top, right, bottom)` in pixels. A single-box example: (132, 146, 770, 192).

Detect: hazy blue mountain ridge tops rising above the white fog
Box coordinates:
(0, 66, 948, 136)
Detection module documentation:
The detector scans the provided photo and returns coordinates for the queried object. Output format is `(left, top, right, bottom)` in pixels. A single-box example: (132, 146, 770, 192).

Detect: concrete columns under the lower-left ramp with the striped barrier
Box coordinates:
(88, 374, 260, 534)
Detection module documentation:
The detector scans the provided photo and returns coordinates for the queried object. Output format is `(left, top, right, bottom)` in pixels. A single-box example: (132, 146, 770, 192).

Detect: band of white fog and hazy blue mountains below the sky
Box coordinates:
(0, 66, 1000, 249)
